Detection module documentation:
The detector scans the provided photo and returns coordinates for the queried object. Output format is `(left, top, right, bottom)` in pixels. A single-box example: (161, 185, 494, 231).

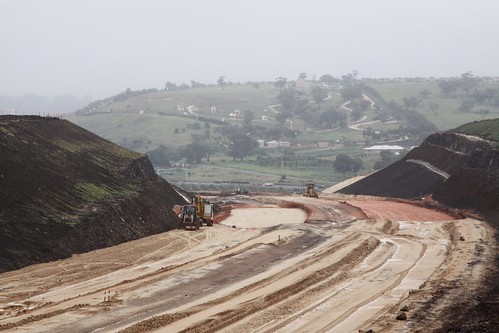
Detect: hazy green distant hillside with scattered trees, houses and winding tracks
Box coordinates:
(67, 73, 499, 189)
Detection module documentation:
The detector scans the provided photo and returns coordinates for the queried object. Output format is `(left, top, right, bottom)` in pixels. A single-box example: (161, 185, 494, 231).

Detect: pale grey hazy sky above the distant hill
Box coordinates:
(0, 0, 499, 98)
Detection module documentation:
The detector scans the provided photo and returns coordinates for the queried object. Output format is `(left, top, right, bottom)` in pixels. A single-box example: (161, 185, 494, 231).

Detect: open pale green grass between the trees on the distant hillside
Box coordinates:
(67, 76, 499, 187)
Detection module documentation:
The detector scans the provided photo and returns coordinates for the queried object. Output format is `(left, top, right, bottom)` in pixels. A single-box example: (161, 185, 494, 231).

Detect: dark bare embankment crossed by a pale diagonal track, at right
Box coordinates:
(338, 132, 499, 209)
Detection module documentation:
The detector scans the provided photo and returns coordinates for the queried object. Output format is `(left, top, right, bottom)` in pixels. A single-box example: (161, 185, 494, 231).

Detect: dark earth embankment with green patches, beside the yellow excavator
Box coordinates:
(0, 116, 184, 272)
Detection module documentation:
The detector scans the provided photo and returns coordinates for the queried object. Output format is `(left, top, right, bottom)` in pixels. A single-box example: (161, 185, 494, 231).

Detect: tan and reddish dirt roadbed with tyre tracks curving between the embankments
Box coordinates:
(0, 196, 495, 333)
